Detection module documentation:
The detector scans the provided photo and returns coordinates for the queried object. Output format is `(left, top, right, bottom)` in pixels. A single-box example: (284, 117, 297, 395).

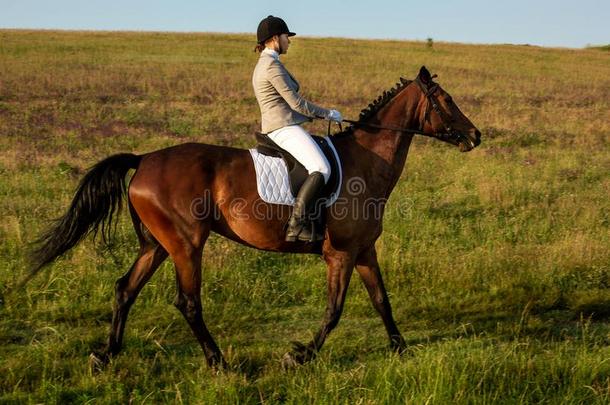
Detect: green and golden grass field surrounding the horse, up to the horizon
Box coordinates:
(0, 30, 610, 404)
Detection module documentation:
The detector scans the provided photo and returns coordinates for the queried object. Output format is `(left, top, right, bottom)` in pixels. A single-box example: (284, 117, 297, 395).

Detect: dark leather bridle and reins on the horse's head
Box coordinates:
(328, 75, 474, 147)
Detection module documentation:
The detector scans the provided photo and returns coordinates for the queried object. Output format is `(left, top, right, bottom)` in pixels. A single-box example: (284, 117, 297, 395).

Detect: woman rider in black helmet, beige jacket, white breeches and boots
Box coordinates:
(252, 15, 342, 242)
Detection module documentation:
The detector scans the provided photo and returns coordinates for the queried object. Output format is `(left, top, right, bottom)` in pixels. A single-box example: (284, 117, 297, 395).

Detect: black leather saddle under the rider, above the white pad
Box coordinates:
(256, 132, 341, 199)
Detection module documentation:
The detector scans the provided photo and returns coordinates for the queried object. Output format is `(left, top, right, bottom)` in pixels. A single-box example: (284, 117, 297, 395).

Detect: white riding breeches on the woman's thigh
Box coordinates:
(267, 125, 330, 183)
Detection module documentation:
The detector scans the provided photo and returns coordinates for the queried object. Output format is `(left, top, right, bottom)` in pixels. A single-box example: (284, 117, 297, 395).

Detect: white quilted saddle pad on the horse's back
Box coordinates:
(250, 138, 343, 207)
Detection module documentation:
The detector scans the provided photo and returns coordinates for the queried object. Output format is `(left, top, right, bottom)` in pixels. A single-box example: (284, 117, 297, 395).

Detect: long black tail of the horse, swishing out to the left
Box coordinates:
(20, 153, 141, 285)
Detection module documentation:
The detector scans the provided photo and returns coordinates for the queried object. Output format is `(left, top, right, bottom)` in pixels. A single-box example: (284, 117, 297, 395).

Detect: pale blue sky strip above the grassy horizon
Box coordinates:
(0, 0, 610, 48)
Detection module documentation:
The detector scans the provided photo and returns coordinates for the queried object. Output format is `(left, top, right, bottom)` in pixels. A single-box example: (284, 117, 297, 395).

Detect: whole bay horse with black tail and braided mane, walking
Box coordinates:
(24, 66, 481, 367)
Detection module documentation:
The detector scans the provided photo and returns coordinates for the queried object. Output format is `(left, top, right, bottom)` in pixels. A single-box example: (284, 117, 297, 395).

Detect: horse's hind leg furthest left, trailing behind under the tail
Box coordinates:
(103, 205, 167, 361)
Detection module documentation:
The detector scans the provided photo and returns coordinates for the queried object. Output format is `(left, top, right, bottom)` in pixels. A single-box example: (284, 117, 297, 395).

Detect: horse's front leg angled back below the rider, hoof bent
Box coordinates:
(282, 242, 355, 367)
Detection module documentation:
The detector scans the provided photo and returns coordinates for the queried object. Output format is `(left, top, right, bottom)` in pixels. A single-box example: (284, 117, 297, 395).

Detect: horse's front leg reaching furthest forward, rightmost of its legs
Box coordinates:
(356, 246, 407, 352)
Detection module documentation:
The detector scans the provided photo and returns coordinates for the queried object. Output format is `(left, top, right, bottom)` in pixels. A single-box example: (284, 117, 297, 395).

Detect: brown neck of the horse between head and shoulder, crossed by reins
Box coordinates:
(342, 86, 420, 195)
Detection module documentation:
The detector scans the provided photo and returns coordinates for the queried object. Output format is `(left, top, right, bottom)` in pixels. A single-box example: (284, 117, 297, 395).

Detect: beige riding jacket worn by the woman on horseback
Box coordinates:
(252, 51, 329, 133)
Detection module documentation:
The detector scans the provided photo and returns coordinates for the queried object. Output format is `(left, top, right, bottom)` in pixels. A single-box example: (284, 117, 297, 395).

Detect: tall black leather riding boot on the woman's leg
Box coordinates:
(286, 172, 324, 242)
